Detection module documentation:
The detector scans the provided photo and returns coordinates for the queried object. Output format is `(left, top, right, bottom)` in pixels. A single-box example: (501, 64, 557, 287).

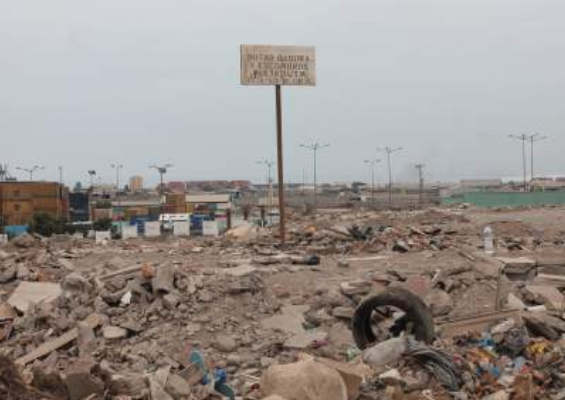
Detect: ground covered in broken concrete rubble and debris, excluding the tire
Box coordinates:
(0, 208, 565, 400)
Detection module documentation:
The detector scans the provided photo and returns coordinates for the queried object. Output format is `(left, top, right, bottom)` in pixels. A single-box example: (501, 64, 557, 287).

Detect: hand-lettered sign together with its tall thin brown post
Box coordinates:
(241, 44, 316, 244)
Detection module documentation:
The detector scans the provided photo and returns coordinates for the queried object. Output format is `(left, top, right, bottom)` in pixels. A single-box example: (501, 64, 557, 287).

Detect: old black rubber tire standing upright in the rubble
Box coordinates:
(351, 288, 434, 350)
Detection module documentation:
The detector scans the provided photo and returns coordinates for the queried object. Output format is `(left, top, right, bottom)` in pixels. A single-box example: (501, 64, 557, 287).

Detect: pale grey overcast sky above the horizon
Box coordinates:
(0, 0, 565, 188)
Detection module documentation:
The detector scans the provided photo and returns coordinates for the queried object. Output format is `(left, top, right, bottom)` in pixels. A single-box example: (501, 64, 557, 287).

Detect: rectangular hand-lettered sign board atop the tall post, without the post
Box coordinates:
(241, 44, 316, 86)
